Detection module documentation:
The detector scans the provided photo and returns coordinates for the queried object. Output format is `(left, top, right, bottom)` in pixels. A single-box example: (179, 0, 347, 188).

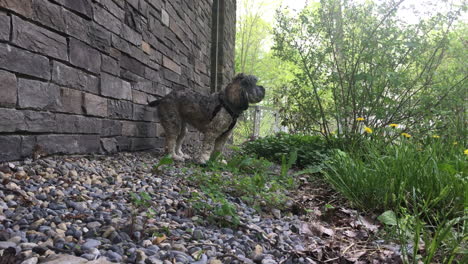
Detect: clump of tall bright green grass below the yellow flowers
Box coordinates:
(323, 131, 468, 263)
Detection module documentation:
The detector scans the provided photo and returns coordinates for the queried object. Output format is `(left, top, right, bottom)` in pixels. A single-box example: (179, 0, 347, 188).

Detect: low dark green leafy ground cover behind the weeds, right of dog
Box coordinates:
(242, 133, 329, 168)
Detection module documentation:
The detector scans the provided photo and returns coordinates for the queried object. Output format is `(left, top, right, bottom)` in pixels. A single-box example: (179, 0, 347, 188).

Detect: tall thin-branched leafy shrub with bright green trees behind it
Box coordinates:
(274, 0, 467, 141)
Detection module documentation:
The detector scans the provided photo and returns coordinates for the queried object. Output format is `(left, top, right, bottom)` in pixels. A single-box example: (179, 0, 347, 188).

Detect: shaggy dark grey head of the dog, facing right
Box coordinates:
(224, 73, 265, 111)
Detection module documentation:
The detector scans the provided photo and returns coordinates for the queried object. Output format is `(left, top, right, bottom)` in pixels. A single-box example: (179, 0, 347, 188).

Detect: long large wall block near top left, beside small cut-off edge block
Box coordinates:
(12, 16, 68, 60)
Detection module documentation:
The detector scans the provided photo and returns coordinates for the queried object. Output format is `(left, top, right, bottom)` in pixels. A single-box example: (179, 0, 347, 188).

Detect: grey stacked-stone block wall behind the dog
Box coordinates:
(0, 0, 235, 161)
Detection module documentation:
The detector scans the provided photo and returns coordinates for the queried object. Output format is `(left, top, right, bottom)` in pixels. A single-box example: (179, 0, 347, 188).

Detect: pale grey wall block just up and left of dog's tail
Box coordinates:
(101, 73, 132, 100)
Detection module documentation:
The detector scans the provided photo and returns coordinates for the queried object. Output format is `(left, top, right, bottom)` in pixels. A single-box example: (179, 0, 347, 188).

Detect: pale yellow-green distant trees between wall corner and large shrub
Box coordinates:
(233, 0, 295, 144)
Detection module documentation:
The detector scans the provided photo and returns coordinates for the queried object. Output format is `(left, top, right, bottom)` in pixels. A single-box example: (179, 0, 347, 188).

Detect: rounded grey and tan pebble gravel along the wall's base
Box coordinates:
(0, 153, 400, 264)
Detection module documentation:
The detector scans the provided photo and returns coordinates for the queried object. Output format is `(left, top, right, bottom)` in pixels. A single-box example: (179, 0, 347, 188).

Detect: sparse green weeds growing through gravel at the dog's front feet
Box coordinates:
(189, 154, 296, 226)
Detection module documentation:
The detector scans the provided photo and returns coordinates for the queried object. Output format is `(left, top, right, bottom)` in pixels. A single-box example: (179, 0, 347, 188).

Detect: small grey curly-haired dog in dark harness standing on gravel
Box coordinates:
(149, 73, 265, 164)
